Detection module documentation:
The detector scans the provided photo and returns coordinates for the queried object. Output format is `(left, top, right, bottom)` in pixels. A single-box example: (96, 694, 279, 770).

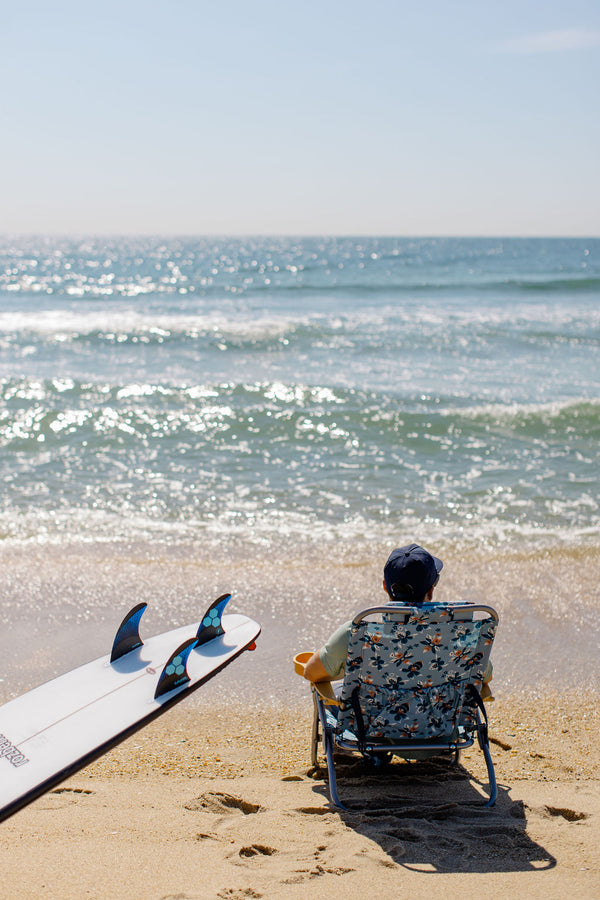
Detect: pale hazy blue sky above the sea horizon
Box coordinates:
(0, 0, 600, 236)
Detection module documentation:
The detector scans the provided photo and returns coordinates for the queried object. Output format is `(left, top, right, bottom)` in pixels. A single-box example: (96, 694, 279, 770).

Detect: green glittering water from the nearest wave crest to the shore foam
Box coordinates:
(0, 378, 600, 548)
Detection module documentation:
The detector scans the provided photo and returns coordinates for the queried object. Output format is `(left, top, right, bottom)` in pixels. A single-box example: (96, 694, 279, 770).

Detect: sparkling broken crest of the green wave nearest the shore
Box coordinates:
(0, 377, 600, 436)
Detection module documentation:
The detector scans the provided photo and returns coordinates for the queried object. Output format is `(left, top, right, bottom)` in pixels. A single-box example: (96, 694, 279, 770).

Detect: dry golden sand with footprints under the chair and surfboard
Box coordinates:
(0, 694, 600, 900)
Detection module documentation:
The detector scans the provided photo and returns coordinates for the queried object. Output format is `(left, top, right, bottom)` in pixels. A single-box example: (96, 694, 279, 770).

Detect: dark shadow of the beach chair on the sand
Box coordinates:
(312, 759, 556, 873)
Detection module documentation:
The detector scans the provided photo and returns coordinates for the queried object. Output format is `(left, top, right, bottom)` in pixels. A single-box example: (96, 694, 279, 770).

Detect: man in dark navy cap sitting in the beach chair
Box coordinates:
(304, 544, 492, 699)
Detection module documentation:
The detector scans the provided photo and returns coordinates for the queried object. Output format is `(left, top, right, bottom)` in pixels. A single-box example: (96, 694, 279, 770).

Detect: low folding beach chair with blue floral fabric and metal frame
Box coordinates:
(296, 604, 498, 809)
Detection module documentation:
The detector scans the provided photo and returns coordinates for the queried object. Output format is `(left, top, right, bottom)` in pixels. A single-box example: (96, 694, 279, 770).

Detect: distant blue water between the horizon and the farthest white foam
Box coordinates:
(0, 236, 600, 299)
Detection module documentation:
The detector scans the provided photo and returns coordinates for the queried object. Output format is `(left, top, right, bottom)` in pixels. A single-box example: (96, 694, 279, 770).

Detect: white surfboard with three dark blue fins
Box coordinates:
(0, 594, 260, 821)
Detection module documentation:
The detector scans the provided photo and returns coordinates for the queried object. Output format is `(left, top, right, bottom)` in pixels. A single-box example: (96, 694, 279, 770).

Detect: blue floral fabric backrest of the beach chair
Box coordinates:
(337, 604, 498, 742)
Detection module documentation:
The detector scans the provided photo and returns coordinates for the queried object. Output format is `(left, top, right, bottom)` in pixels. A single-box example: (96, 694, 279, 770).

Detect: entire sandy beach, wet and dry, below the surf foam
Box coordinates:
(0, 547, 600, 900)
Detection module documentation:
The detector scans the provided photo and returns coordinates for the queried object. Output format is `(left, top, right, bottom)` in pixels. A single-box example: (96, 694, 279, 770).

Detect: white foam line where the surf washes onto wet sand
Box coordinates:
(0, 492, 600, 557)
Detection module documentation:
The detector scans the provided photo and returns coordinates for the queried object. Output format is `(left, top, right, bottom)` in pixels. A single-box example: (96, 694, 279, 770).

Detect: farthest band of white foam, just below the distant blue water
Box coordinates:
(0, 303, 600, 345)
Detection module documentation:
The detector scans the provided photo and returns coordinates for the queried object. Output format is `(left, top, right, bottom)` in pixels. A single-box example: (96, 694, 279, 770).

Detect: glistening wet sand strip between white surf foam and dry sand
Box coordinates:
(0, 541, 600, 704)
